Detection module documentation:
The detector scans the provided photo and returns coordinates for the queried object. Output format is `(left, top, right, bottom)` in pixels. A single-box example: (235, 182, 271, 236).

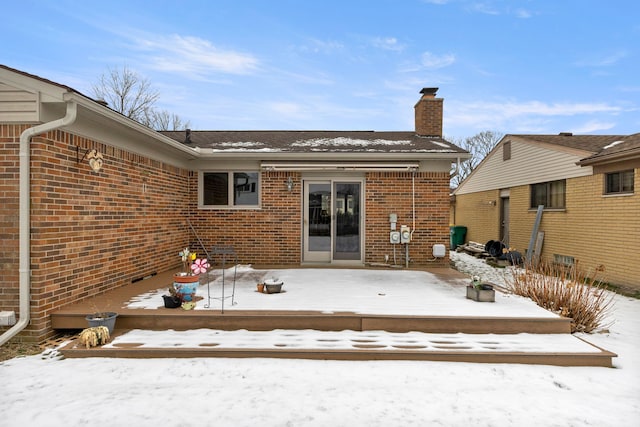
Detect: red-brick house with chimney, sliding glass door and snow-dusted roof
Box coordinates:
(0, 65, 469, 340)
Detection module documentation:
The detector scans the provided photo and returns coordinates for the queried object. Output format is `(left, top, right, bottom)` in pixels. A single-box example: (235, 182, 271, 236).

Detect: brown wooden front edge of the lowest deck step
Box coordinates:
(61, 342, 616, 368)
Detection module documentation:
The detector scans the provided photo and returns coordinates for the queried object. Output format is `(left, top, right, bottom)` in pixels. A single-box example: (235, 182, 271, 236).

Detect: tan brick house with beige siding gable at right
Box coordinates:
(452, 133, 640, 290)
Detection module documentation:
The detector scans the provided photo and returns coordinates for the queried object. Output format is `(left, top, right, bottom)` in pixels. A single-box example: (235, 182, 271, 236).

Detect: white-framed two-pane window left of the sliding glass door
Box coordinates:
(202, 172, 260, 207)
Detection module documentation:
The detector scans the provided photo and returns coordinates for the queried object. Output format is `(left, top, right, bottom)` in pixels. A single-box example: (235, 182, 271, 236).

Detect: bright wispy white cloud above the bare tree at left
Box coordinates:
(136, 34, 259, 75)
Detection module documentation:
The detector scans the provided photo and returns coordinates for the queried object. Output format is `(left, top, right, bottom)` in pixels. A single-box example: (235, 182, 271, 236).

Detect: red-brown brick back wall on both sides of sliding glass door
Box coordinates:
(185, 172, 449, 266)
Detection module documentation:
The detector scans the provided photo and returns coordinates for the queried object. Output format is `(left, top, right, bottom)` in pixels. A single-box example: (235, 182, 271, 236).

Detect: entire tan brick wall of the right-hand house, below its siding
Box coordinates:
(456, 172, 640, 289)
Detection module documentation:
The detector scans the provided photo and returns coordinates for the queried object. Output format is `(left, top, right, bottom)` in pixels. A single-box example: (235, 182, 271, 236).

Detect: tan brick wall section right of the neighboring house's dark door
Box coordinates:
(511, 175, 640, 289)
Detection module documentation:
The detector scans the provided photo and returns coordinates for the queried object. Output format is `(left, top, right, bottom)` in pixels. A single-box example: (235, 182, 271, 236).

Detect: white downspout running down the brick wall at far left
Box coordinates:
(0, 101, 78, 346)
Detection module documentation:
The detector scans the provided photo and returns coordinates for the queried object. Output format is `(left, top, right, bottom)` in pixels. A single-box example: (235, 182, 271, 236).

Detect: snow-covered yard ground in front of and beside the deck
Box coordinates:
(0, 253, 640, 427)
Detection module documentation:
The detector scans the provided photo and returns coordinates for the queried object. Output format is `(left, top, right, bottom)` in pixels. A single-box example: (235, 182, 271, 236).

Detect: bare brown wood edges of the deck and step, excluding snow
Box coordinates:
(51, 269, 616, 366)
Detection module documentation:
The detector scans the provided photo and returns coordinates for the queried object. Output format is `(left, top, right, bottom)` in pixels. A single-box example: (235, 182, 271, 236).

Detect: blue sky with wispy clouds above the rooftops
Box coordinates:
(0, 0, 640, 139)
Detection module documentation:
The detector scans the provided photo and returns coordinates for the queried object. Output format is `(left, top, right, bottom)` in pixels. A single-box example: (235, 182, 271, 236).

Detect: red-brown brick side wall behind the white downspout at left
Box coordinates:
(0, 125, 194, 340)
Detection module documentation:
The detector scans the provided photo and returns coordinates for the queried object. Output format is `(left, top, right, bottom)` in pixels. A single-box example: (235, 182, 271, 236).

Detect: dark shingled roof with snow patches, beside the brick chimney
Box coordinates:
(161, 131, 466, 153)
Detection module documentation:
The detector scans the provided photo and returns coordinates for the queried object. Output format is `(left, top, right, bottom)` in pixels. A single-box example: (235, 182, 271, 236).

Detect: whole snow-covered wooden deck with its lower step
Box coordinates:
(52, 266, 615, 366)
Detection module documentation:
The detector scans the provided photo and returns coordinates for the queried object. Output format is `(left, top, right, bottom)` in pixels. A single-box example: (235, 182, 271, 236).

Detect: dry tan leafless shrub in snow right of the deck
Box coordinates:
(505, 262, 613, 333)
